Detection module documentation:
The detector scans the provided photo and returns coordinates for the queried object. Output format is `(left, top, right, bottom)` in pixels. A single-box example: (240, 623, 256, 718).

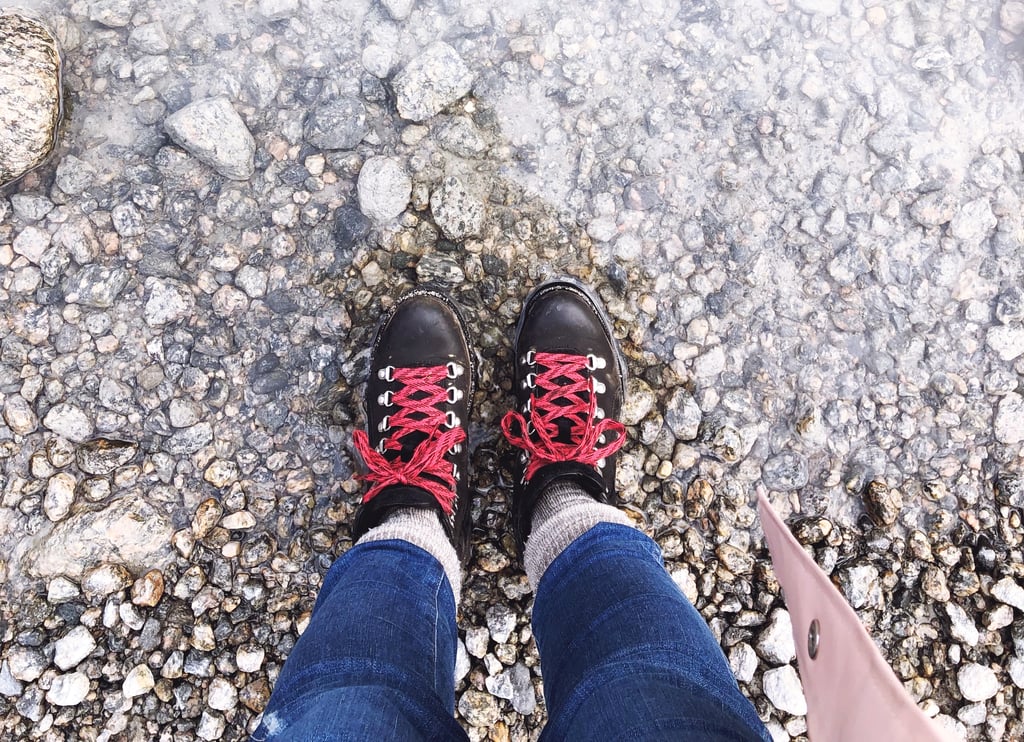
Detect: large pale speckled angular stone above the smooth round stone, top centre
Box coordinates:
(393, 41, 475, 121)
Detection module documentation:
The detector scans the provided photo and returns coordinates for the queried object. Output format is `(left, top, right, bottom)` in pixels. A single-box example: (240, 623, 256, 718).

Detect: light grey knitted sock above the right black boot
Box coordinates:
(522, 482, 632, 593)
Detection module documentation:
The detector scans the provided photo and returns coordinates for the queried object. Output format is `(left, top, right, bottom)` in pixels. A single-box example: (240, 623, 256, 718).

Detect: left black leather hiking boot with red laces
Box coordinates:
(352, 289, 475, 563)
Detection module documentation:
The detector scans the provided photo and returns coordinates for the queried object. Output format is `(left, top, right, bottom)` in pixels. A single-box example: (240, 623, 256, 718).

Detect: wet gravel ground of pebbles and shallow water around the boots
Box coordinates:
(0, 0, 1024, 741)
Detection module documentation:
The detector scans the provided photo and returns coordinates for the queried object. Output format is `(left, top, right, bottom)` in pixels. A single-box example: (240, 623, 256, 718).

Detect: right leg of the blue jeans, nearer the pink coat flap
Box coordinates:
(526, 500, 771, 742)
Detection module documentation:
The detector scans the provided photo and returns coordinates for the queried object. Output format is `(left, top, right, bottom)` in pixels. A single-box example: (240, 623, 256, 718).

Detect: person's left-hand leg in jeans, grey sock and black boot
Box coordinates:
(253, 290, 474, 742)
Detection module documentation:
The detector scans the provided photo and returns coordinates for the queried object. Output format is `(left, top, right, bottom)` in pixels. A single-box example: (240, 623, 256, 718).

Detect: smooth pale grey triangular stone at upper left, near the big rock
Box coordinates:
(164, 96, 256, 180)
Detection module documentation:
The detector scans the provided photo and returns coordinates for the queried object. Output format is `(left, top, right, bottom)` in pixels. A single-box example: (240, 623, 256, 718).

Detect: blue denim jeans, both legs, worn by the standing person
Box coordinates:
(253, 523, 771, 742)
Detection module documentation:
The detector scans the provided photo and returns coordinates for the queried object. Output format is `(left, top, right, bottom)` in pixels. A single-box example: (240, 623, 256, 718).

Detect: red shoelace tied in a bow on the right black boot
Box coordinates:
(502, 353, 626, 481)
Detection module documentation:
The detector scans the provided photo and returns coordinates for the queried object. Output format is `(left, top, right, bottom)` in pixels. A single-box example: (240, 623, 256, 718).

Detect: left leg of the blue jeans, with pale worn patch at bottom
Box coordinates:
(253, 521, 465, 742)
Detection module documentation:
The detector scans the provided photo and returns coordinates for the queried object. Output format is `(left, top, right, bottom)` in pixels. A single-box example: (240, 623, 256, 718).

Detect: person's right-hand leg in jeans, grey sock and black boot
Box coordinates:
(502, 280, 770, 742)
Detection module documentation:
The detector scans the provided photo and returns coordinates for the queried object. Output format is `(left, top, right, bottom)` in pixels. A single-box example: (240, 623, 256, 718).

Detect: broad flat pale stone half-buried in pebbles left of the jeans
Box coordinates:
(23, 494, 174, 579)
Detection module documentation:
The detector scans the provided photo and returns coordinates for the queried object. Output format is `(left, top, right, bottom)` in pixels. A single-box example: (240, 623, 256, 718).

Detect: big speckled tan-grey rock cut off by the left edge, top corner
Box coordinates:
(0, 11, 62, 185)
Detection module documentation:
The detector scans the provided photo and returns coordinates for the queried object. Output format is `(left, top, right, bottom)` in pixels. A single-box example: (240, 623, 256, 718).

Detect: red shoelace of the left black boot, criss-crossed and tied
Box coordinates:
(352, 365, 466, 515)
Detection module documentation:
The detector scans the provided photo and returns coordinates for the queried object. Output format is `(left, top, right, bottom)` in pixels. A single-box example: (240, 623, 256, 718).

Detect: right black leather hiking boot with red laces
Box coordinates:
(502, 278, 626, 554)
